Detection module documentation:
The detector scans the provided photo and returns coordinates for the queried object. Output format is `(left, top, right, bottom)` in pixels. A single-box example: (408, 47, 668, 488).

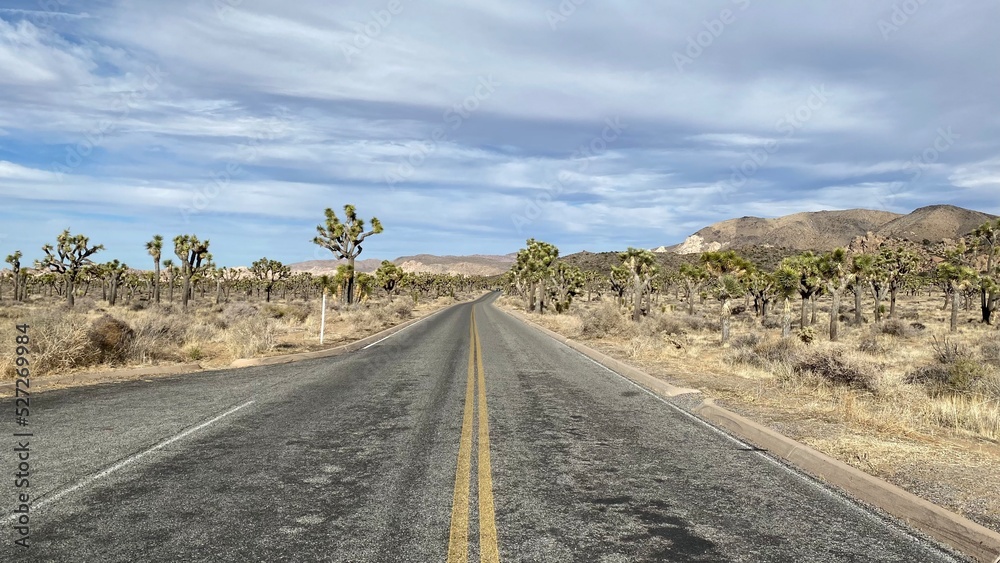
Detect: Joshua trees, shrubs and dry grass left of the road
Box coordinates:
(0, 205, 489, 378)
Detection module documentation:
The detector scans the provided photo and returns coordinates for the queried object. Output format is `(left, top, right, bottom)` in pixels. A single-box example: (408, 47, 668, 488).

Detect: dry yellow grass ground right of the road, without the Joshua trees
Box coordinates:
(503, 294, 1000, 530)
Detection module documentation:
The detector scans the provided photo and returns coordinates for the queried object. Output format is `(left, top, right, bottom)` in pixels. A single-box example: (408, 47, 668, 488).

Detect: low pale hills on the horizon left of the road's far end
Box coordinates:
(290, 254, 514, 276)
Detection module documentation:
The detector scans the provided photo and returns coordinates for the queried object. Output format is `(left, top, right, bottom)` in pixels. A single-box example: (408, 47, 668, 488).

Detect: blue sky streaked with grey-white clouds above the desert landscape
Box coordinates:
(0, 0, 1000, 265)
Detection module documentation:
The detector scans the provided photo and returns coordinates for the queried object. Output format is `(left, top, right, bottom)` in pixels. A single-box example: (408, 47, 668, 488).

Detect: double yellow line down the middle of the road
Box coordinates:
(448, 309, 500, 563)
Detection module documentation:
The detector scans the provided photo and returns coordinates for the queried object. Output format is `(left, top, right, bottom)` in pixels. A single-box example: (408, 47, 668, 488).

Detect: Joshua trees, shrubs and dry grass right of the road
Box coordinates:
(500, 230, 1000, 528)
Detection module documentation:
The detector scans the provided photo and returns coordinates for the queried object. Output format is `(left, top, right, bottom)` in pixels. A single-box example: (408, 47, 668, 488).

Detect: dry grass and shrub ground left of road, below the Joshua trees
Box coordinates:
(0, 290, 464, 378)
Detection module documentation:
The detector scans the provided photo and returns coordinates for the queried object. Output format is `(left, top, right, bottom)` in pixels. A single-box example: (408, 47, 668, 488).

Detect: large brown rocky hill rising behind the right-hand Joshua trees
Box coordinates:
(656, 205, 995, 254)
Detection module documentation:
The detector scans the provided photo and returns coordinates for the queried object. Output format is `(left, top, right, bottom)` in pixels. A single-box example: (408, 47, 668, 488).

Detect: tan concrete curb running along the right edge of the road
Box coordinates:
(497, 307, 1000, 563)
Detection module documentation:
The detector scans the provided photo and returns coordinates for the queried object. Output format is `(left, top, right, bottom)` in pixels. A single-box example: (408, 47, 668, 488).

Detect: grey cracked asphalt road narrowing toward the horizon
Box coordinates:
(0, 297, 960, 563)
